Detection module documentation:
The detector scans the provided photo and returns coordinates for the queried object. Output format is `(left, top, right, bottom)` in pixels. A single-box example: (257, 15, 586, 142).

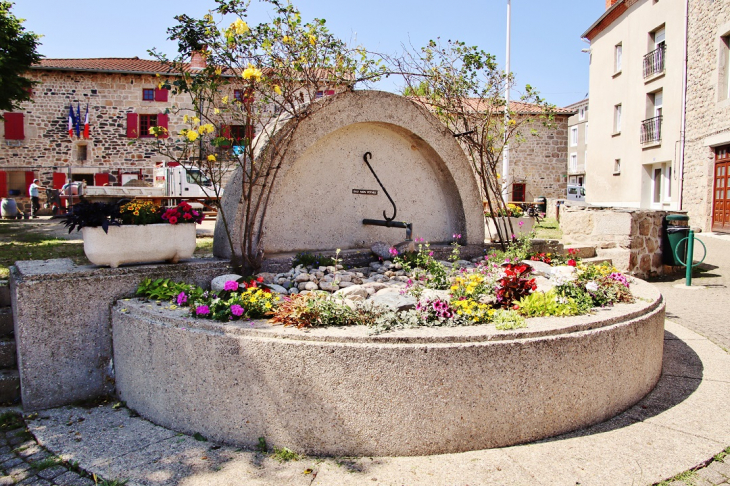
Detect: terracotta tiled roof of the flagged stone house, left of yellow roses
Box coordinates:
(31, 57, 185, 74)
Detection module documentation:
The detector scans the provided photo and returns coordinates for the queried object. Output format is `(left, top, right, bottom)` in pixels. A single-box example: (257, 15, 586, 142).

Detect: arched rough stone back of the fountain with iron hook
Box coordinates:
(214, 91, 484, 257)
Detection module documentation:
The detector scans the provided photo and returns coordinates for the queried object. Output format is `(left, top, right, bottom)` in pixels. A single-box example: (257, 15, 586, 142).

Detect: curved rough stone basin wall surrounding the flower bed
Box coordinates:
(112, 280, 664, 456)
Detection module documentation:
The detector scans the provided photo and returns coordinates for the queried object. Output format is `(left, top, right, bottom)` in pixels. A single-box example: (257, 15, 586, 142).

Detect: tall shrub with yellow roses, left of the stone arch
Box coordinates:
(151, 0, 383, 275)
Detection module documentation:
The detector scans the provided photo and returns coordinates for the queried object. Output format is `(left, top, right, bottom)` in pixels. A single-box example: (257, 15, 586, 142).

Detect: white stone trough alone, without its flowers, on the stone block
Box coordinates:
(82, 223, 195, 268)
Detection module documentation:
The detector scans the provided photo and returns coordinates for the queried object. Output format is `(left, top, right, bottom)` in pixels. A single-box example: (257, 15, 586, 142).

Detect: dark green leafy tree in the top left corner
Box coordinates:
(0, 1, 41, 111)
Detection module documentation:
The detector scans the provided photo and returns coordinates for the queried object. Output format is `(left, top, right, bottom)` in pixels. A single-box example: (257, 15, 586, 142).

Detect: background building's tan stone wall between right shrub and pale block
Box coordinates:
(510, 115, 568, 202)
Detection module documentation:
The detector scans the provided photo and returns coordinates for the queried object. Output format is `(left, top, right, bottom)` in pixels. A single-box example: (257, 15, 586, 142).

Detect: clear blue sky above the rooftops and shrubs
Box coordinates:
(12, 0, 605, 106)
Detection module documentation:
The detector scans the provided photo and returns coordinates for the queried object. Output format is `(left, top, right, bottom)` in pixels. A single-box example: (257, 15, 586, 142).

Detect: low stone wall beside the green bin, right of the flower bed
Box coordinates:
(560, 205, 683, 278)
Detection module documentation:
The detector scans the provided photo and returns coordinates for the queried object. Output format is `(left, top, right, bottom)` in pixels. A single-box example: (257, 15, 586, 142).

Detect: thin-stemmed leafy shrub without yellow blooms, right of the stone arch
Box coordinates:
(389, 40, 554, 246)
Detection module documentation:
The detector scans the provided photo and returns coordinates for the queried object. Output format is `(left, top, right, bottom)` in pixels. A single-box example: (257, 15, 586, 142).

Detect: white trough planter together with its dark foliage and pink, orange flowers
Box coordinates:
(65, 200, 203, 268)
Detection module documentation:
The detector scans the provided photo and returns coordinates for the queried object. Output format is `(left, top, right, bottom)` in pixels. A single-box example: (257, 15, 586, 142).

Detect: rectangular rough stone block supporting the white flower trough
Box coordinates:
(10, 259, 230, 410)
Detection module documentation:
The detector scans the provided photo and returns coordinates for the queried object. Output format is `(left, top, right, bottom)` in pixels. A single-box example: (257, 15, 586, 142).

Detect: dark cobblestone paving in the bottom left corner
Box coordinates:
(0, 408, 100, 486)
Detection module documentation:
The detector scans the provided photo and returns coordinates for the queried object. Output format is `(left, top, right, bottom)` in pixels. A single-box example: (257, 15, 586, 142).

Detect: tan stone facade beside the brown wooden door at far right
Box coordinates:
(682, 0, 730, 230)
